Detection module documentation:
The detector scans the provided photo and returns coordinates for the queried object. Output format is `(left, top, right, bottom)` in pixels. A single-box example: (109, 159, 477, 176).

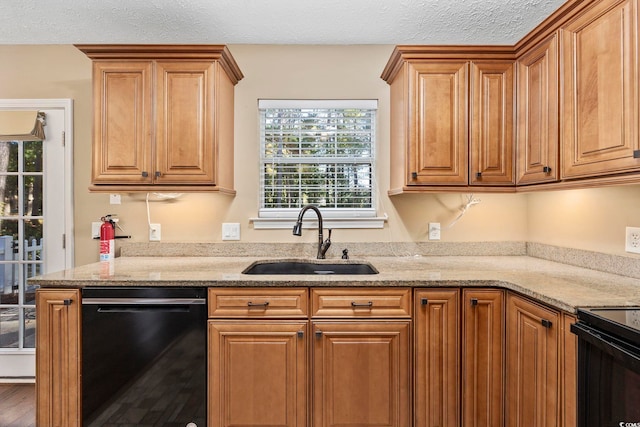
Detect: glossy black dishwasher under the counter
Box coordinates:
(82, 287, 207, 427)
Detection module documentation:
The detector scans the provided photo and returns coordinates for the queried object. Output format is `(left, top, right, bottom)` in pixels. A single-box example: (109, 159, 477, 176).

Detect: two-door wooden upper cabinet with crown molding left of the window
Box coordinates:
(77, 45, 243, 194)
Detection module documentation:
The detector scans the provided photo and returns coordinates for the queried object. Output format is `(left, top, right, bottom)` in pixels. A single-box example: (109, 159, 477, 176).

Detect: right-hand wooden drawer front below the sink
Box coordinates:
(311, 288, 411, 318)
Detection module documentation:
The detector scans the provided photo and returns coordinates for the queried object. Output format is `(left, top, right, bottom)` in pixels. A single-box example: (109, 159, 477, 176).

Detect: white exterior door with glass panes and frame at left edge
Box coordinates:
(0, 99, 73, 381)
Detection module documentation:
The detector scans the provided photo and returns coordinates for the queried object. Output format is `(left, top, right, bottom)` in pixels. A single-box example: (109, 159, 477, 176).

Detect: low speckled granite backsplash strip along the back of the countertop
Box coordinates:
(120, 242, 640, 279)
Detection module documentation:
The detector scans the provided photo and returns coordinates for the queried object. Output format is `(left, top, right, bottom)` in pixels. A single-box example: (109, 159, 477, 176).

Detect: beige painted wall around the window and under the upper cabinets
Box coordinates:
(0, 45, 640, 265)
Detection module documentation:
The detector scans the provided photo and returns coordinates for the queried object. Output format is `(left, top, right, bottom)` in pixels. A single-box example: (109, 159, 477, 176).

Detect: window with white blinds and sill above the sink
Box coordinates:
(254, 100, 382, 228)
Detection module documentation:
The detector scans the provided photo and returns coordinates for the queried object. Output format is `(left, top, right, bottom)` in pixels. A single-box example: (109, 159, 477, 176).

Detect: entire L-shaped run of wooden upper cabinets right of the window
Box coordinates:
(382, 0, 640, 195)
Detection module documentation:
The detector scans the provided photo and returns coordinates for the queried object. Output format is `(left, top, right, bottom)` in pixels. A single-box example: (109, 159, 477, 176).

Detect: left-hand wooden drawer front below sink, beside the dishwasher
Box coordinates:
(209, 288, 309, 318)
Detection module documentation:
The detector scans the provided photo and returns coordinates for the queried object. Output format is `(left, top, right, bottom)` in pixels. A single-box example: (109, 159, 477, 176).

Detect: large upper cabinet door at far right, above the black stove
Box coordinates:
(560, 0, 640, 178)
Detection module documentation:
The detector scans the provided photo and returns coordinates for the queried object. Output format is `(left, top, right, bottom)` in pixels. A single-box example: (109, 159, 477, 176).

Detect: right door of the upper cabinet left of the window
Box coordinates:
(153, 61, 216, 185)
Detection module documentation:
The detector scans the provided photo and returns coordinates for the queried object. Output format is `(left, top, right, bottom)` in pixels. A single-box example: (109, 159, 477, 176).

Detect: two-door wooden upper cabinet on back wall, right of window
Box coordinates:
(382, 46, 515, 194)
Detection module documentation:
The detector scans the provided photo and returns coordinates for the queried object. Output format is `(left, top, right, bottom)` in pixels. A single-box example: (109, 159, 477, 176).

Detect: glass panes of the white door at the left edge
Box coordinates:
(0, 141, 44, 349)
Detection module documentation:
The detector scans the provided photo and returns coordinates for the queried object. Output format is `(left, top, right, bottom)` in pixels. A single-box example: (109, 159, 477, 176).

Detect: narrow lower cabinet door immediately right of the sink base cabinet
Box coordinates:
(414, 289, 460, 427)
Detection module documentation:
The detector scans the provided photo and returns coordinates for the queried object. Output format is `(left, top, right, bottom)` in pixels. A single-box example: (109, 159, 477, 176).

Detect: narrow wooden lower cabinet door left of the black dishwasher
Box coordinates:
(36, 289, 82, 427)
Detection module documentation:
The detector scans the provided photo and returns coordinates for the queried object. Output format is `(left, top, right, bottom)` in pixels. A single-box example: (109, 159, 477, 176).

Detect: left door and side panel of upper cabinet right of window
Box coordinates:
(391, 61, 469, 188)
